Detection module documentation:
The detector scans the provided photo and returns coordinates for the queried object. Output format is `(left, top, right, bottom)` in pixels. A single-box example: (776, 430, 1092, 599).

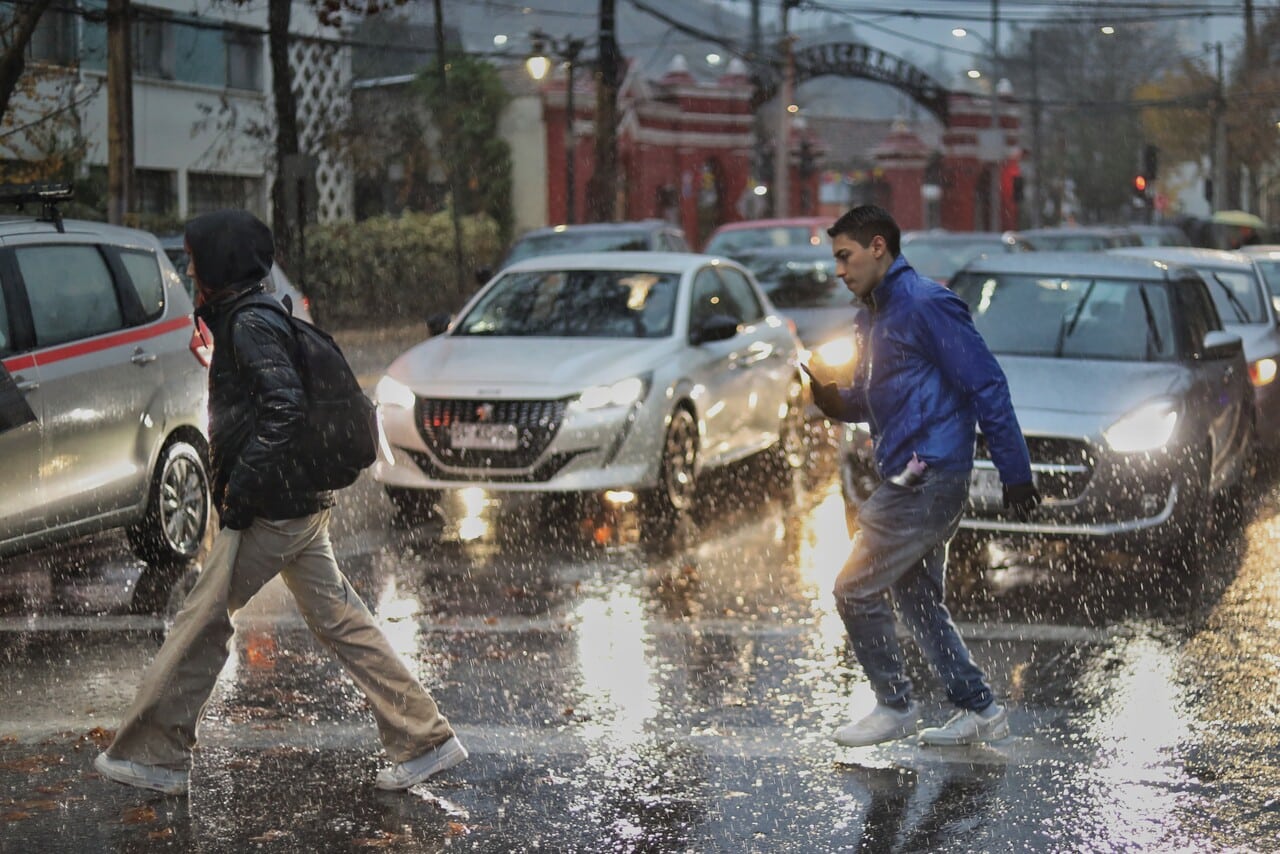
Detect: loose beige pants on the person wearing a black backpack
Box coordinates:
(106, 511, 453, 769)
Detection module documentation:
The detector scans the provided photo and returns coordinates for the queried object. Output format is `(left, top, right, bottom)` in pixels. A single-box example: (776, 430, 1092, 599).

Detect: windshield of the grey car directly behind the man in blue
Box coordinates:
(952, 273, 1175, 361)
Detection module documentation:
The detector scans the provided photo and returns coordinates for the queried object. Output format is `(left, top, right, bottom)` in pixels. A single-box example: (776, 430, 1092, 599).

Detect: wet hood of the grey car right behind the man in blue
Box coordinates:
(997, 356, 1188, 435)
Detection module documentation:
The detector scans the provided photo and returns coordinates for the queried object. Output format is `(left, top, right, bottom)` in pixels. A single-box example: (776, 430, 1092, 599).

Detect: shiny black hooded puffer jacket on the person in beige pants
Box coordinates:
(186, 211, 333, 528)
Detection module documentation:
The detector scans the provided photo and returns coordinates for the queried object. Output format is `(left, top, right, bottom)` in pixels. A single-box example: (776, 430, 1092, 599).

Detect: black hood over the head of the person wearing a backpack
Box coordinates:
(183, 210, 275, 293)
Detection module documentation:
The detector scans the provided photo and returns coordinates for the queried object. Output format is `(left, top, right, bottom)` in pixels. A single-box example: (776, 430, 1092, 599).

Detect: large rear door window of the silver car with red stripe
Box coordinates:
(14, 245, 124, 347)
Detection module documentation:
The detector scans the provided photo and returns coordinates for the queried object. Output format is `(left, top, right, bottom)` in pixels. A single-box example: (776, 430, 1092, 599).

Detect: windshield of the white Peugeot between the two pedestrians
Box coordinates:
(453, 270, 680, 338)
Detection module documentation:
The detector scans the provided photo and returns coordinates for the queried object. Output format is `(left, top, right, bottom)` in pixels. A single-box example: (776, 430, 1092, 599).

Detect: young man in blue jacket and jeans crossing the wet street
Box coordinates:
(813, 205, 1039, 746)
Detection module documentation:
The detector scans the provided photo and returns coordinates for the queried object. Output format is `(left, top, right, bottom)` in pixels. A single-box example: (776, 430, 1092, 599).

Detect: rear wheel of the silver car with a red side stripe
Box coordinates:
(125, 439, 210, 566)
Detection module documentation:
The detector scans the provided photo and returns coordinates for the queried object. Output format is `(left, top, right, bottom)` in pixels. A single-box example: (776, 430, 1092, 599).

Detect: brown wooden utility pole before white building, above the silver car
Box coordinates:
(106, 0, 133, 225)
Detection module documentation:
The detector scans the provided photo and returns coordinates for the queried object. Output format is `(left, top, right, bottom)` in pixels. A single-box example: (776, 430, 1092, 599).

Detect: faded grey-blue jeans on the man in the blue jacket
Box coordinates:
(835, 470, 993, 711)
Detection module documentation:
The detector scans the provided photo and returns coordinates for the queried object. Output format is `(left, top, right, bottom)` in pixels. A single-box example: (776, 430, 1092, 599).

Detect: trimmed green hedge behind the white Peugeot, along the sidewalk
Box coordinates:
(302, 211, 500, 328)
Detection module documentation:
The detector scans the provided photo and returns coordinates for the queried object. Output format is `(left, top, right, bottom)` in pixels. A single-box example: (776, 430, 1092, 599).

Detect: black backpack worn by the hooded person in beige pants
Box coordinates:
(237, 296, 378, 490)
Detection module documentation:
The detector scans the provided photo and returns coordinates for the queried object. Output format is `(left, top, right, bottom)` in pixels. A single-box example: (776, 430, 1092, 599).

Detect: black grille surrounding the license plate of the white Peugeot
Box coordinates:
(415, 398, 568, 470)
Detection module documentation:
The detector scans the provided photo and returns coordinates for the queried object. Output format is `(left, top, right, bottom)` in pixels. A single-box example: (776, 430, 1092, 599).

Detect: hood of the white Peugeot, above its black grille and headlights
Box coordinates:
(387, 335, 680, 398)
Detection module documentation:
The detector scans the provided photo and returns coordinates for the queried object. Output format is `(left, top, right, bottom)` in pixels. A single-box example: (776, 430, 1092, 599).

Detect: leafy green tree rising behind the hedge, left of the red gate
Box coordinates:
(417, 55, 515, 243)
